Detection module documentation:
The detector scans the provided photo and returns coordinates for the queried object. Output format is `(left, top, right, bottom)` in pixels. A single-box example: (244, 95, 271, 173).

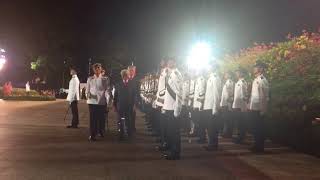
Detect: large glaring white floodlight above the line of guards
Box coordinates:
(187, 42, 212, 69)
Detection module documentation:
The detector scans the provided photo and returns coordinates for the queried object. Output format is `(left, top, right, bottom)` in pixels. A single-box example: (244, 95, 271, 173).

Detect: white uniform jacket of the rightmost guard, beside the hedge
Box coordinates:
(249, 74, 269, 114)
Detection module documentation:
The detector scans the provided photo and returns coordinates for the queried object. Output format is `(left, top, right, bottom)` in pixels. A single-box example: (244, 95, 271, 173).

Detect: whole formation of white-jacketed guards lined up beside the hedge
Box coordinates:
(139, 58, 269, 160)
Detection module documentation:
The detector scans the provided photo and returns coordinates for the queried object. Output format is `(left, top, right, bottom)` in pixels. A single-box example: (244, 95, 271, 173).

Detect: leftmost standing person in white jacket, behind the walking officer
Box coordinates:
(64, 68, 80, 128)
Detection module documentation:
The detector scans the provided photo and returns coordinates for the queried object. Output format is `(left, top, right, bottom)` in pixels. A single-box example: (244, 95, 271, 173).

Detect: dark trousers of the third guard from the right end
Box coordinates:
(221, 107, 234, 137)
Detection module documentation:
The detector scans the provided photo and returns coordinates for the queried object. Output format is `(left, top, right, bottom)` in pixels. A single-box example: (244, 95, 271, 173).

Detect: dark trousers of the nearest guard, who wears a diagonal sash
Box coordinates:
(165, 111, 181, 156)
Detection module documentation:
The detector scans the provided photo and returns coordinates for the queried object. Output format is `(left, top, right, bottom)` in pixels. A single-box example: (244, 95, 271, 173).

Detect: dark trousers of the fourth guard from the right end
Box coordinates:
(203, 110, 221, 147)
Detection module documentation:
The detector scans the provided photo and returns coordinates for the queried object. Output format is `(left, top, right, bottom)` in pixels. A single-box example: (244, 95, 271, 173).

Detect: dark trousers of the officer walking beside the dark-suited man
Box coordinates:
(89, 104, 105, 137)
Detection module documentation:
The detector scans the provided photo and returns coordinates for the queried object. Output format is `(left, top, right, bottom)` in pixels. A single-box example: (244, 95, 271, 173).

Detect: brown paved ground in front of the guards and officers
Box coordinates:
(0, 100, 320, 180)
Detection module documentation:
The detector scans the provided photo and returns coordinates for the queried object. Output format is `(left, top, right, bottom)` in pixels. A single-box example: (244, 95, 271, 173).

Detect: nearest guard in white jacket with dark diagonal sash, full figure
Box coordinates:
(162, 60, 183, 160)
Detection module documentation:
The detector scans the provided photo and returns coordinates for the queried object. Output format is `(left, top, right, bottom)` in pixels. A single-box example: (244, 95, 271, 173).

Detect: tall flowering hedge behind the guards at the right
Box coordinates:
(221, 31, 320, 155)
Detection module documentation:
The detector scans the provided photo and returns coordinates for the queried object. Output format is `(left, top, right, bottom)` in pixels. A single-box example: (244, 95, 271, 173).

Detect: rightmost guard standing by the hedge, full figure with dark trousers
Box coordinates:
(249, 62, 269, 153)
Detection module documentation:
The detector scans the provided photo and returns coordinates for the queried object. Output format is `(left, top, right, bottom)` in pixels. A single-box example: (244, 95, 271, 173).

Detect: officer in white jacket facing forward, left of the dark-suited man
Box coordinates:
(86, 63, 109, 141)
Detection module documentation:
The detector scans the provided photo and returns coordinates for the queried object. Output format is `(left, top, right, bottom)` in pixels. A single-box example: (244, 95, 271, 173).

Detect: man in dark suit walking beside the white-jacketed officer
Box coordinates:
(113, 70, 132, 140)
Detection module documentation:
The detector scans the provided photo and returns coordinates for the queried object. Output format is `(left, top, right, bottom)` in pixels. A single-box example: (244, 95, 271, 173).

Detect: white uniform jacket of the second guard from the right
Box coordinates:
(232, 78, 248, 112)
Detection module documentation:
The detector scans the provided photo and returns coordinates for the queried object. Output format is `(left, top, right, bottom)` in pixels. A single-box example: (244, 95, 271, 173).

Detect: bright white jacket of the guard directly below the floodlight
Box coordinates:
(193, 76, 206, 110)
